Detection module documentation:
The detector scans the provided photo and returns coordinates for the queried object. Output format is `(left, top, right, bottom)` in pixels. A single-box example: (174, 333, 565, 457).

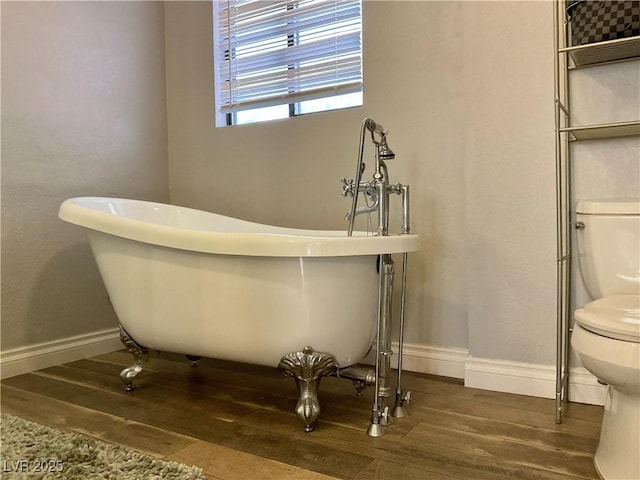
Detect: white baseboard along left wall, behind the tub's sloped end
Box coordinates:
(0, 328, 122, 379)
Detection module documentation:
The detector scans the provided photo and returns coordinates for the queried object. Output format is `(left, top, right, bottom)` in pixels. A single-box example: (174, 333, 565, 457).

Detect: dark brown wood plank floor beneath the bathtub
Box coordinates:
(1, 352, 602, 480)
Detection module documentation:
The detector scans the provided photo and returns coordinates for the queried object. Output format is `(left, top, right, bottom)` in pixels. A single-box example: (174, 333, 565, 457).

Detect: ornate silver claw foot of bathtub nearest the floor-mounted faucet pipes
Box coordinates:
(278, 347, 337, 432)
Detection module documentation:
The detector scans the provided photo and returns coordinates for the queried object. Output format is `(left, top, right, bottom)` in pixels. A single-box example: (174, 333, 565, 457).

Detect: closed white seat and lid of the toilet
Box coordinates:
(575, 295, 640, 343)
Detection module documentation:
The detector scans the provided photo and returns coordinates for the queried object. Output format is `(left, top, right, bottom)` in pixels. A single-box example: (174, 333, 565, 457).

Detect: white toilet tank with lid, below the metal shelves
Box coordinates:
(576, 201, 640, 299)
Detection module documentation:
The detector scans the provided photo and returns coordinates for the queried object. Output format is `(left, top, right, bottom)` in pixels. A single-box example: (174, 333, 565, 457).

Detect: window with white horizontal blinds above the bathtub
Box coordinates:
(213, 0, 362, 125)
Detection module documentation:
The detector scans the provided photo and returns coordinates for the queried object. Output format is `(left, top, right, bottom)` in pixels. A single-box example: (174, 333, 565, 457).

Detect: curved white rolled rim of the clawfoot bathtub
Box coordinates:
(58, 197, 420, 257)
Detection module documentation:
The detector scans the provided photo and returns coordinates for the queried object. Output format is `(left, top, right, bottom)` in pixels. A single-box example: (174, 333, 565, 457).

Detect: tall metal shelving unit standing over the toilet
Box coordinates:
(554, 0, 640, 423)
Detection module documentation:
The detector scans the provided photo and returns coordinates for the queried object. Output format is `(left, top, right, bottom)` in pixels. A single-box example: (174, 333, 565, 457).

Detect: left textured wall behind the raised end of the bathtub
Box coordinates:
(1, 1, 168, 351)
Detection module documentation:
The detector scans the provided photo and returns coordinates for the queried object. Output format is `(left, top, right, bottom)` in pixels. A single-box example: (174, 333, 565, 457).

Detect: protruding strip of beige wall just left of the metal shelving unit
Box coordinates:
(459, 2, 556, 364)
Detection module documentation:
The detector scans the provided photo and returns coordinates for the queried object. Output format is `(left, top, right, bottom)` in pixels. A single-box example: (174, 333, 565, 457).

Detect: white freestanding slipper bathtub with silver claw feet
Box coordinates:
(59, 197, 418, 430)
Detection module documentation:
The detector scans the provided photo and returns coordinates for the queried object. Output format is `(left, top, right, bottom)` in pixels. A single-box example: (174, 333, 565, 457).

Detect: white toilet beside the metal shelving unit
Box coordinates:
(571, 201, 640, 480)
